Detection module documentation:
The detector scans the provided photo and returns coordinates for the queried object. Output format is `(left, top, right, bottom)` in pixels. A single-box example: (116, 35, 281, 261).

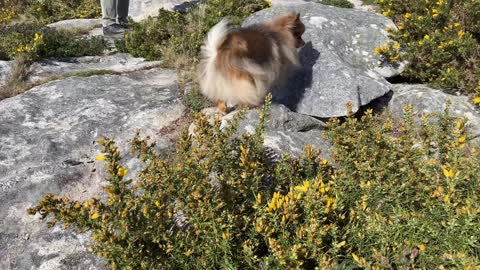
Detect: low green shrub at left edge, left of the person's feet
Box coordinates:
(0, 23, 106, 60)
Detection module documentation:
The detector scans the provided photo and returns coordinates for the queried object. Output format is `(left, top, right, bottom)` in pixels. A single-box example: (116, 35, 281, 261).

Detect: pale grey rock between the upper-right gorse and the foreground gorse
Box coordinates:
(387, 84, 480, 137)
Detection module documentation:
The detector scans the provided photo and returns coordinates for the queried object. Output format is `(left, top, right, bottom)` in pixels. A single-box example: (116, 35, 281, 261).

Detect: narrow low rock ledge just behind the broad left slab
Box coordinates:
(28, 53, 162, 83)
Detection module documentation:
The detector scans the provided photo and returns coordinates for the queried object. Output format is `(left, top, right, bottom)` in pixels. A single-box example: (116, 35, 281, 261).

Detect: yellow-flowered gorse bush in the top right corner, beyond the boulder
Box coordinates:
(376, 0, 480, 95)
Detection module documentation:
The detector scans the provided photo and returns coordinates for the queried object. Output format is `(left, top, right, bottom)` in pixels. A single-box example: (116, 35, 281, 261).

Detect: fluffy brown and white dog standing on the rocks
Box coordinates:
(199, 13, 305, 114)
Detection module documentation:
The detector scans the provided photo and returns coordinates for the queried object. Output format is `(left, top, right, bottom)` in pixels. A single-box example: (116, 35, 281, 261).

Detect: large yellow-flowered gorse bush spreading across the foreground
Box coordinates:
(29, 96, 480, 269)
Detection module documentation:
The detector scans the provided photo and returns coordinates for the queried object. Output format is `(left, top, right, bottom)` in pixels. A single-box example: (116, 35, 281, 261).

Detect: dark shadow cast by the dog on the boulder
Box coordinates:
(273, 41, 320, 111)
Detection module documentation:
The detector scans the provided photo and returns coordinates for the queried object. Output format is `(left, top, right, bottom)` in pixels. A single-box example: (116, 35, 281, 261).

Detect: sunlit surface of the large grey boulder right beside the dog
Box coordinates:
(244, 1, 402, 118)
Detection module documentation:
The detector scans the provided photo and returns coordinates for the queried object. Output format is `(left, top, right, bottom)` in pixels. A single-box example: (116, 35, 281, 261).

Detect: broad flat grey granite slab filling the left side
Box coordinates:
(0, 69, 184, 269)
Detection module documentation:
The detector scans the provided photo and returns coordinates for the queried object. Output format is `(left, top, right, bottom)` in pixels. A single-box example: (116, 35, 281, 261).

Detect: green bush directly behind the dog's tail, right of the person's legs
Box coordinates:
(117, 0, 270, 63)
